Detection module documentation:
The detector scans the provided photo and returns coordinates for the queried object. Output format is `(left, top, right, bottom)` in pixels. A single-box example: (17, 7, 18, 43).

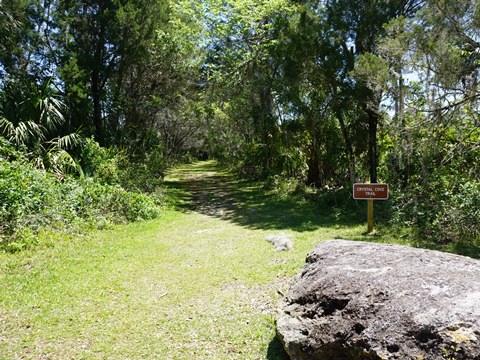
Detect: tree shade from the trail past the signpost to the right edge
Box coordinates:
(165, 161, 480, 259)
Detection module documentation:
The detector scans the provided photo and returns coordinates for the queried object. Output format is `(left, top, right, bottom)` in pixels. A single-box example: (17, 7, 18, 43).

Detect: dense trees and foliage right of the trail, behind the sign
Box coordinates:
(200, 0, 480, 245)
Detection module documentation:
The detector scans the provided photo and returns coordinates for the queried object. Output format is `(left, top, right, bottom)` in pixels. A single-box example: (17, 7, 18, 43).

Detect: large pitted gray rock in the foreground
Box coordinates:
(277, 240, 480, 360)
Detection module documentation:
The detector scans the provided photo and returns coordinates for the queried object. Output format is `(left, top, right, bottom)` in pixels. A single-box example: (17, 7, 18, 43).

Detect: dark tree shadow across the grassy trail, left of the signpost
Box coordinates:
(165, 162, 359, 232)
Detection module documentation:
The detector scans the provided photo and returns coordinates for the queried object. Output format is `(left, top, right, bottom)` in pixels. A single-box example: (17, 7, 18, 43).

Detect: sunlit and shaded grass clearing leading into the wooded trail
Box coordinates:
(0, 162, 404, 360)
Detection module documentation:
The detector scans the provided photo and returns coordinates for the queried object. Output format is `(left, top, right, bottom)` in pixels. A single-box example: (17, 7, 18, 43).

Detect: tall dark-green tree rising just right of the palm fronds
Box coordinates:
(56, 0, 172, 144)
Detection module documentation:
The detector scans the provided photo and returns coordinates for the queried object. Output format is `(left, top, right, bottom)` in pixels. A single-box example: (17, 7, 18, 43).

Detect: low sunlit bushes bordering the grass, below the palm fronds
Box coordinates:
(0, 153, 162, 252)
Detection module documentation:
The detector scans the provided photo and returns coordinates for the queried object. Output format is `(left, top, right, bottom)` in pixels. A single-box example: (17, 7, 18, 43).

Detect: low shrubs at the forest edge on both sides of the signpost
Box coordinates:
(244, 172, 480, 258)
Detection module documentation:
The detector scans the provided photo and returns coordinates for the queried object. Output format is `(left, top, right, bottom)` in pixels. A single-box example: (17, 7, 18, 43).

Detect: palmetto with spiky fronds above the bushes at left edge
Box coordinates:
(0, 80, 81, 177)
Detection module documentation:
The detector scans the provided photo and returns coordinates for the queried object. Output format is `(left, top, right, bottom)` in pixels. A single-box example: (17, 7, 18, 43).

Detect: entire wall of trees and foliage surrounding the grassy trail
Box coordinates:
(0, 0, 480, 250)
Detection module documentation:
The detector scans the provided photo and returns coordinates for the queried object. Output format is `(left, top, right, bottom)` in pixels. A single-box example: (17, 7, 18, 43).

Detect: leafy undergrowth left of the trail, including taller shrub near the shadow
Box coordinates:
(0, 139, 163, 252)
